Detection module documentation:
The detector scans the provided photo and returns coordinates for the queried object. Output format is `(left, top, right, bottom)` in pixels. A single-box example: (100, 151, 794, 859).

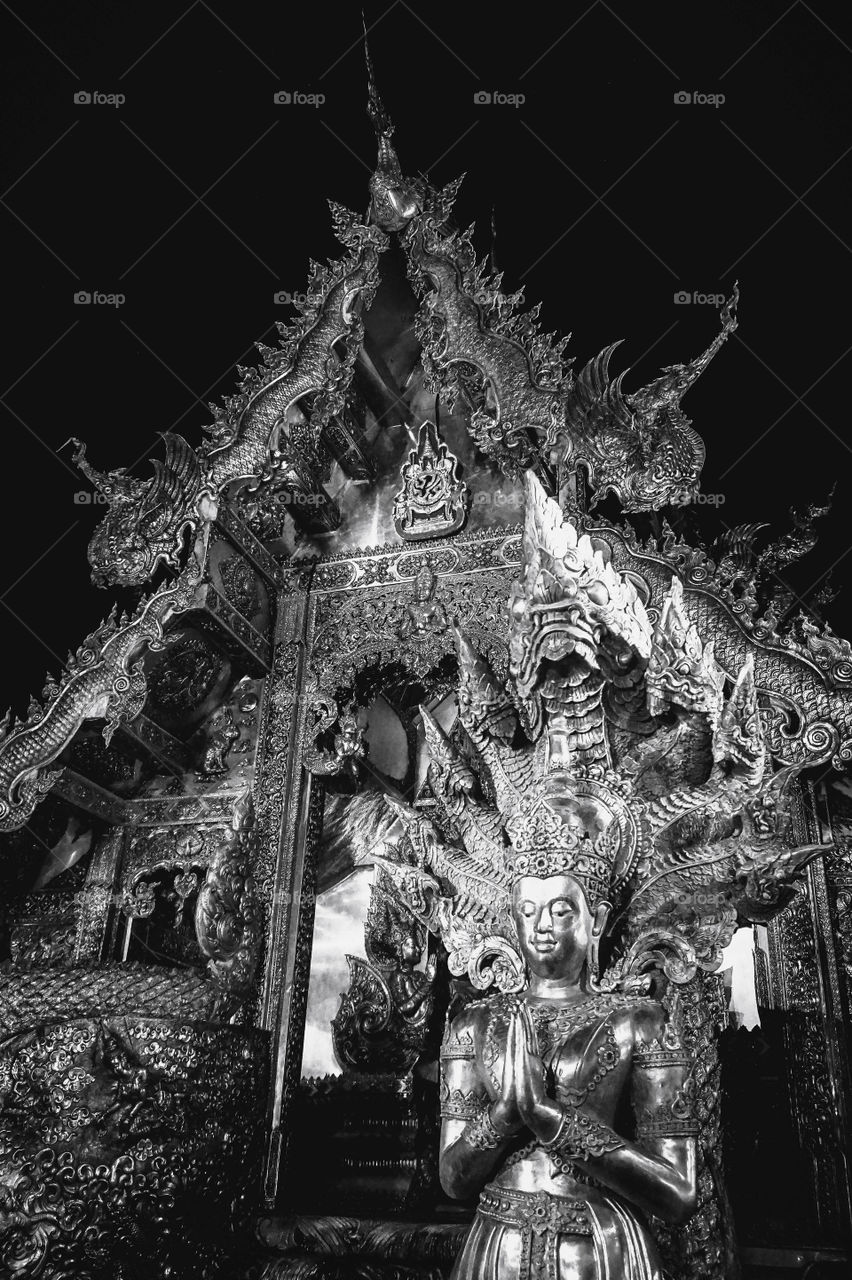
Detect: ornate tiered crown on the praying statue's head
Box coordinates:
(505, 786, 622, 906)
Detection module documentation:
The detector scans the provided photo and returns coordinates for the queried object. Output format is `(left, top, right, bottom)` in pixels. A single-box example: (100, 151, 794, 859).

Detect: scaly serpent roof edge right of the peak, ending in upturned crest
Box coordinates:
(403, 165, 738, 511)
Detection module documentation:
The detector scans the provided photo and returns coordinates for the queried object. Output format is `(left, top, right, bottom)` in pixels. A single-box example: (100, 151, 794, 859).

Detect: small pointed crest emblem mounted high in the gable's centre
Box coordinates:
(394, 422, 467, 541)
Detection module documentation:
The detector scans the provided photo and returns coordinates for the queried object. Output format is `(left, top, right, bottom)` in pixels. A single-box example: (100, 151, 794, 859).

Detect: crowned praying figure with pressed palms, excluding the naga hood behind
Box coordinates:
(440, 793, 696, 1280)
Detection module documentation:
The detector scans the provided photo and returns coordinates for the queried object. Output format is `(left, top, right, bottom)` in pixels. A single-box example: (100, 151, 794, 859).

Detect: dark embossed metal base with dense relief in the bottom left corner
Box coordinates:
(0, 1015, 265, 1277)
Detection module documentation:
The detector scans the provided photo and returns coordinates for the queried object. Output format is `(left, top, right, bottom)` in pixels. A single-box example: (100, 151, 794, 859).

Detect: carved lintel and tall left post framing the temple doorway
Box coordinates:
(255, 527, 521, 1207)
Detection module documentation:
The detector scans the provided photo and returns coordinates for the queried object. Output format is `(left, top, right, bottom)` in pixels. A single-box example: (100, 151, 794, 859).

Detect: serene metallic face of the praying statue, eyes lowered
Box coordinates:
(512, 876, 592, 980)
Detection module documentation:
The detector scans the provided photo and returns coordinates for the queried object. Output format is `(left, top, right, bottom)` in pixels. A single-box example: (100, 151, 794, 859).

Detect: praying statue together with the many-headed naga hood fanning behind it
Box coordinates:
(376, 475, 824, 1280)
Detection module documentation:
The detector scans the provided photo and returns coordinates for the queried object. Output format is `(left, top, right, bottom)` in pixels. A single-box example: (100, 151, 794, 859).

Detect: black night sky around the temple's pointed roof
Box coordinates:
(0, 0, 852, 708)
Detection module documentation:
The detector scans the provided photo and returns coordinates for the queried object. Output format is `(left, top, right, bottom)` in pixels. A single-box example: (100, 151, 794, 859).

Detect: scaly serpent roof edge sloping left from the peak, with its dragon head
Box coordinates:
(68, 213, 388, 586)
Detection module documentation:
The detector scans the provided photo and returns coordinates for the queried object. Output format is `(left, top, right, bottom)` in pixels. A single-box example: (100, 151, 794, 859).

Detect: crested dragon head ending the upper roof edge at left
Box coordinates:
(72, 433, 202, 586)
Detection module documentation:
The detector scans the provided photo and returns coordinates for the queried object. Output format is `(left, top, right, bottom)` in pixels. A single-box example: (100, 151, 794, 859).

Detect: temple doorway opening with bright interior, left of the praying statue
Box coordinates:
(284, 655, 475, 1222)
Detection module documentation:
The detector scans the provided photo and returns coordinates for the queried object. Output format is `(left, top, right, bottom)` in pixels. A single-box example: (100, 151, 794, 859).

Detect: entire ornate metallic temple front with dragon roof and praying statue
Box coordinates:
(0, 47, 852, 1280)
